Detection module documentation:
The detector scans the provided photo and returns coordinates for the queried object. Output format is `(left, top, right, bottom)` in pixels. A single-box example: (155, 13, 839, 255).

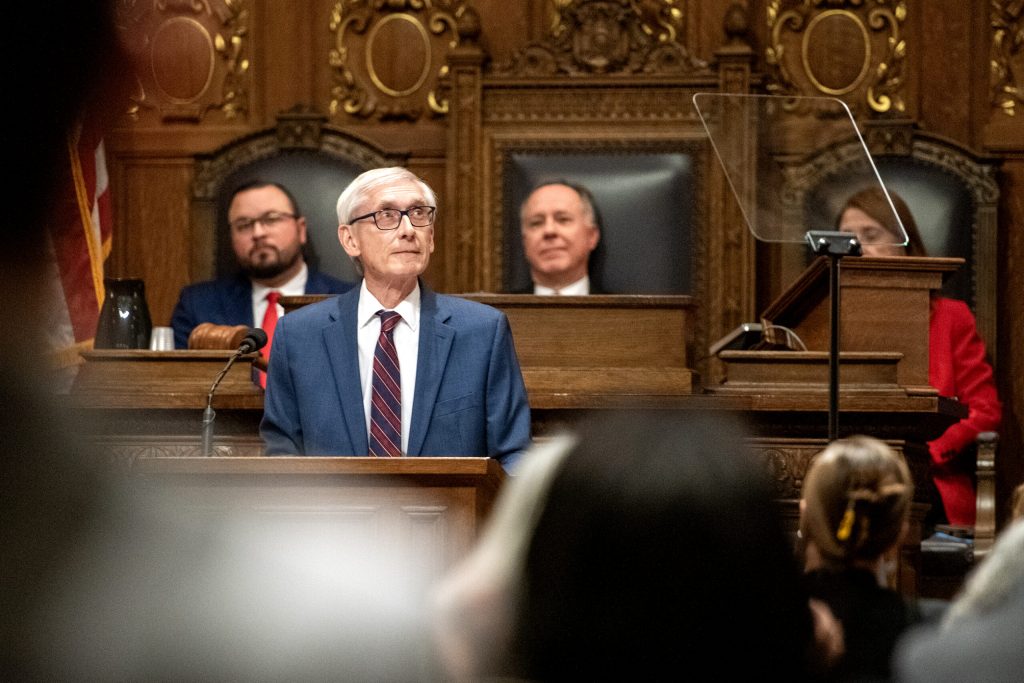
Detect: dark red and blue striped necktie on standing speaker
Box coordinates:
(370, 310, 402, 458)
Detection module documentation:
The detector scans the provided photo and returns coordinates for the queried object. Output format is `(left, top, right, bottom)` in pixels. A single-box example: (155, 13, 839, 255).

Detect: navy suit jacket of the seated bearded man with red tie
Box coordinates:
(171, 270, 352, 348)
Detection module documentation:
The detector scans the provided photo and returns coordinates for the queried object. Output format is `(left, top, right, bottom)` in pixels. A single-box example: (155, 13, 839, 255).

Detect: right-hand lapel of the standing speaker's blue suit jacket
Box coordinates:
(409, 284, 455, 456)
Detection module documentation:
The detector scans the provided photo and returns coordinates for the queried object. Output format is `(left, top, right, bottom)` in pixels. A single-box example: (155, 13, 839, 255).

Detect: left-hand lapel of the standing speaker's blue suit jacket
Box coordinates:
(322, 287, 370, 456)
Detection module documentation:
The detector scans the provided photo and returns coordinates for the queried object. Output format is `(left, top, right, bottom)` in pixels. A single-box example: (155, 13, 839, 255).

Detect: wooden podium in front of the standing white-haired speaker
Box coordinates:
(130, 457, 505, 580)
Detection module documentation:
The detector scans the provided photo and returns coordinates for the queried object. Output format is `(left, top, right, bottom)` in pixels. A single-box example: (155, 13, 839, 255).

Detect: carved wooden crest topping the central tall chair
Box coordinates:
(493, 0, 707, 77)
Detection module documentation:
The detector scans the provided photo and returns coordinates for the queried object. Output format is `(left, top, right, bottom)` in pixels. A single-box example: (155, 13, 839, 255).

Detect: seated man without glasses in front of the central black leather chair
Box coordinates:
(519, 180, 601, 296)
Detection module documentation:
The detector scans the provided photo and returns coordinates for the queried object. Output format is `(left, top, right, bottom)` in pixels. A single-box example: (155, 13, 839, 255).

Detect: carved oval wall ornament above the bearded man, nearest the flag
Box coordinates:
(118, 0, 249, 121)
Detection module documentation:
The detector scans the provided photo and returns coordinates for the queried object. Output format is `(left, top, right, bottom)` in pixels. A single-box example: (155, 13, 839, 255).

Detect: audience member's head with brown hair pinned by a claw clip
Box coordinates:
(800, 436, 913, 567)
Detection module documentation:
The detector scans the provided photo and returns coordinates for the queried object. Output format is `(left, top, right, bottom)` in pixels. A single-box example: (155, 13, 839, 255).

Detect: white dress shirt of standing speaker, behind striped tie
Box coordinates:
(355, 280, 420, 454)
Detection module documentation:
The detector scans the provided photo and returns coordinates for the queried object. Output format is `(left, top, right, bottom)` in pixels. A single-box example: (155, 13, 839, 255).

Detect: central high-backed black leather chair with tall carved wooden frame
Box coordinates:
(439, 0, 756, 382)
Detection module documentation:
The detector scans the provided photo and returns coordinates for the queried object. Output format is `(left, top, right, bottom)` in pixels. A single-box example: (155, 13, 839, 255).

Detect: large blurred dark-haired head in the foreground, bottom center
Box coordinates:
(511, 412, 811, 680)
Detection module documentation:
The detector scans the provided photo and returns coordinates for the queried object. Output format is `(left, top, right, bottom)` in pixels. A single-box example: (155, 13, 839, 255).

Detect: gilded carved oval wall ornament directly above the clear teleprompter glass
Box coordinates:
(765, 0, 906, 116)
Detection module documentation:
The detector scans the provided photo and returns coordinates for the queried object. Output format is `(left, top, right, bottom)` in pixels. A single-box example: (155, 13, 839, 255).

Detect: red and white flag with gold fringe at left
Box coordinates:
(47, 120, 113, 368)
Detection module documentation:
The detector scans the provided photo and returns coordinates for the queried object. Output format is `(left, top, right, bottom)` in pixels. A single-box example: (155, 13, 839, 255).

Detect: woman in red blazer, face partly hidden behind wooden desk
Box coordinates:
(839, 187, 1002, 525)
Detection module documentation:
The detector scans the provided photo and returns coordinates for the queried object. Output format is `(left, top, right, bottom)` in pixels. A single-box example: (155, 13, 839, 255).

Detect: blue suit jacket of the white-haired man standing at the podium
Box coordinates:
(260, 285, 530, 467)
